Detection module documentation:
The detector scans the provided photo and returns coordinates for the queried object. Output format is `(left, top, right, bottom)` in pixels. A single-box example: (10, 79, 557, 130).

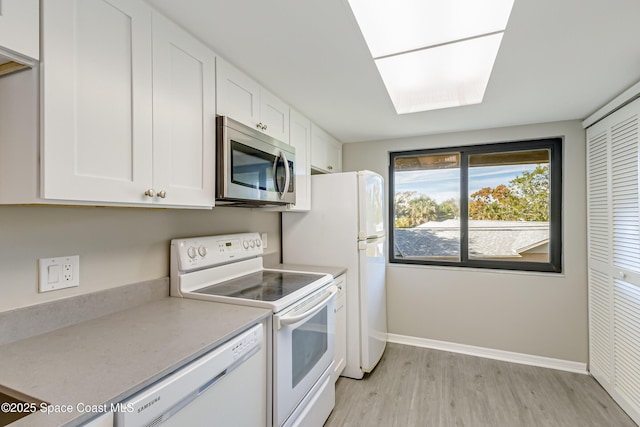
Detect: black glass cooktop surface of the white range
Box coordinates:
(194, 270, 323, 301)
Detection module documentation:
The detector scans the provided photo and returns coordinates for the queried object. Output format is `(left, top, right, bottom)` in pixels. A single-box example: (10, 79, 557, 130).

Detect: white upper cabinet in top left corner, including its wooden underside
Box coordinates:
(0, 0, 40, 76)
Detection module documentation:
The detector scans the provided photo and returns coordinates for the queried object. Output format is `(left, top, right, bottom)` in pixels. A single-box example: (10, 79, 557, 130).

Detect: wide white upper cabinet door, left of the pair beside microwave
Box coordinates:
(41, 0, 152, 203)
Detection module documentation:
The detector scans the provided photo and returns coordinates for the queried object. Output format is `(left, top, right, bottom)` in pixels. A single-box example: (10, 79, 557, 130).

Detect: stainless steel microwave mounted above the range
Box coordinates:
(216, 117, 296, 206)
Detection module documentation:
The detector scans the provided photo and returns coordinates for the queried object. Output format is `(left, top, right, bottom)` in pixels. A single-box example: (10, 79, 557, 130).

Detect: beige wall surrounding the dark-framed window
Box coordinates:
(343, 121, 588, 363)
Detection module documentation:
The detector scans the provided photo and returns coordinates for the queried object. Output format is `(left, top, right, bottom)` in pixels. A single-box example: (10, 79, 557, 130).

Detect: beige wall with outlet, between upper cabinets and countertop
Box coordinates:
(0, 206, 280, 311)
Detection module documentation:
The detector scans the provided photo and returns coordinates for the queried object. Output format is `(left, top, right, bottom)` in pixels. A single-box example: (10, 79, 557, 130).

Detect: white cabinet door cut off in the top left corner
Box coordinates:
(0, 0, 40, 63)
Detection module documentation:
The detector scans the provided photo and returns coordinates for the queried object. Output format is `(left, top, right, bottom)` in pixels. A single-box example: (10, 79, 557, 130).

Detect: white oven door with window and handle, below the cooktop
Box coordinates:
(273, 285, 337, 426)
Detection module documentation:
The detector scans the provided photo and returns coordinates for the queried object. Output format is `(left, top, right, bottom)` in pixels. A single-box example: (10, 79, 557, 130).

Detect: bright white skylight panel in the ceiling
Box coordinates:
(348, 0, 514, 114)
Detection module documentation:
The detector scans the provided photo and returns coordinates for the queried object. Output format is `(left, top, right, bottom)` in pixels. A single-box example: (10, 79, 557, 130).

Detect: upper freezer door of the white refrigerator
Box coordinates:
(358, 171, 385, 240)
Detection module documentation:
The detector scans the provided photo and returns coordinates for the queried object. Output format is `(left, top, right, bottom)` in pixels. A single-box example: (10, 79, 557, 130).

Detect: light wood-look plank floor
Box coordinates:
(325, 344, 636, 427)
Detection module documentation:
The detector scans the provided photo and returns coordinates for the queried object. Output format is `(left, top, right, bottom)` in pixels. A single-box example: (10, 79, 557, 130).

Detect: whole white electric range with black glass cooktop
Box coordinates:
(171, 233, 337, 427)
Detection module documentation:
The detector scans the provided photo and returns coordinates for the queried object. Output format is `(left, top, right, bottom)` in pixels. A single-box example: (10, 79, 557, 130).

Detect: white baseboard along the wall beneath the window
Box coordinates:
(387, 334, 589, 375)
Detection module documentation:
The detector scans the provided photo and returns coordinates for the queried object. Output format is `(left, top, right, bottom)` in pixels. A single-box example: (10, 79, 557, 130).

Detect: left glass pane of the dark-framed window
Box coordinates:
(393, 153, 460, 261)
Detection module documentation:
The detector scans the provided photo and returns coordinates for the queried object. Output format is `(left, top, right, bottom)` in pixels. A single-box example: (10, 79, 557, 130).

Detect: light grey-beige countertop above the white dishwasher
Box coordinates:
(0, 297, 271, 427)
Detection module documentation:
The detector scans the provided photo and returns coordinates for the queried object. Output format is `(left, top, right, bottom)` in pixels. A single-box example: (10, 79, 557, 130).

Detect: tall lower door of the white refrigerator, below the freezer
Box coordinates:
(358, 237, 387, 372)
